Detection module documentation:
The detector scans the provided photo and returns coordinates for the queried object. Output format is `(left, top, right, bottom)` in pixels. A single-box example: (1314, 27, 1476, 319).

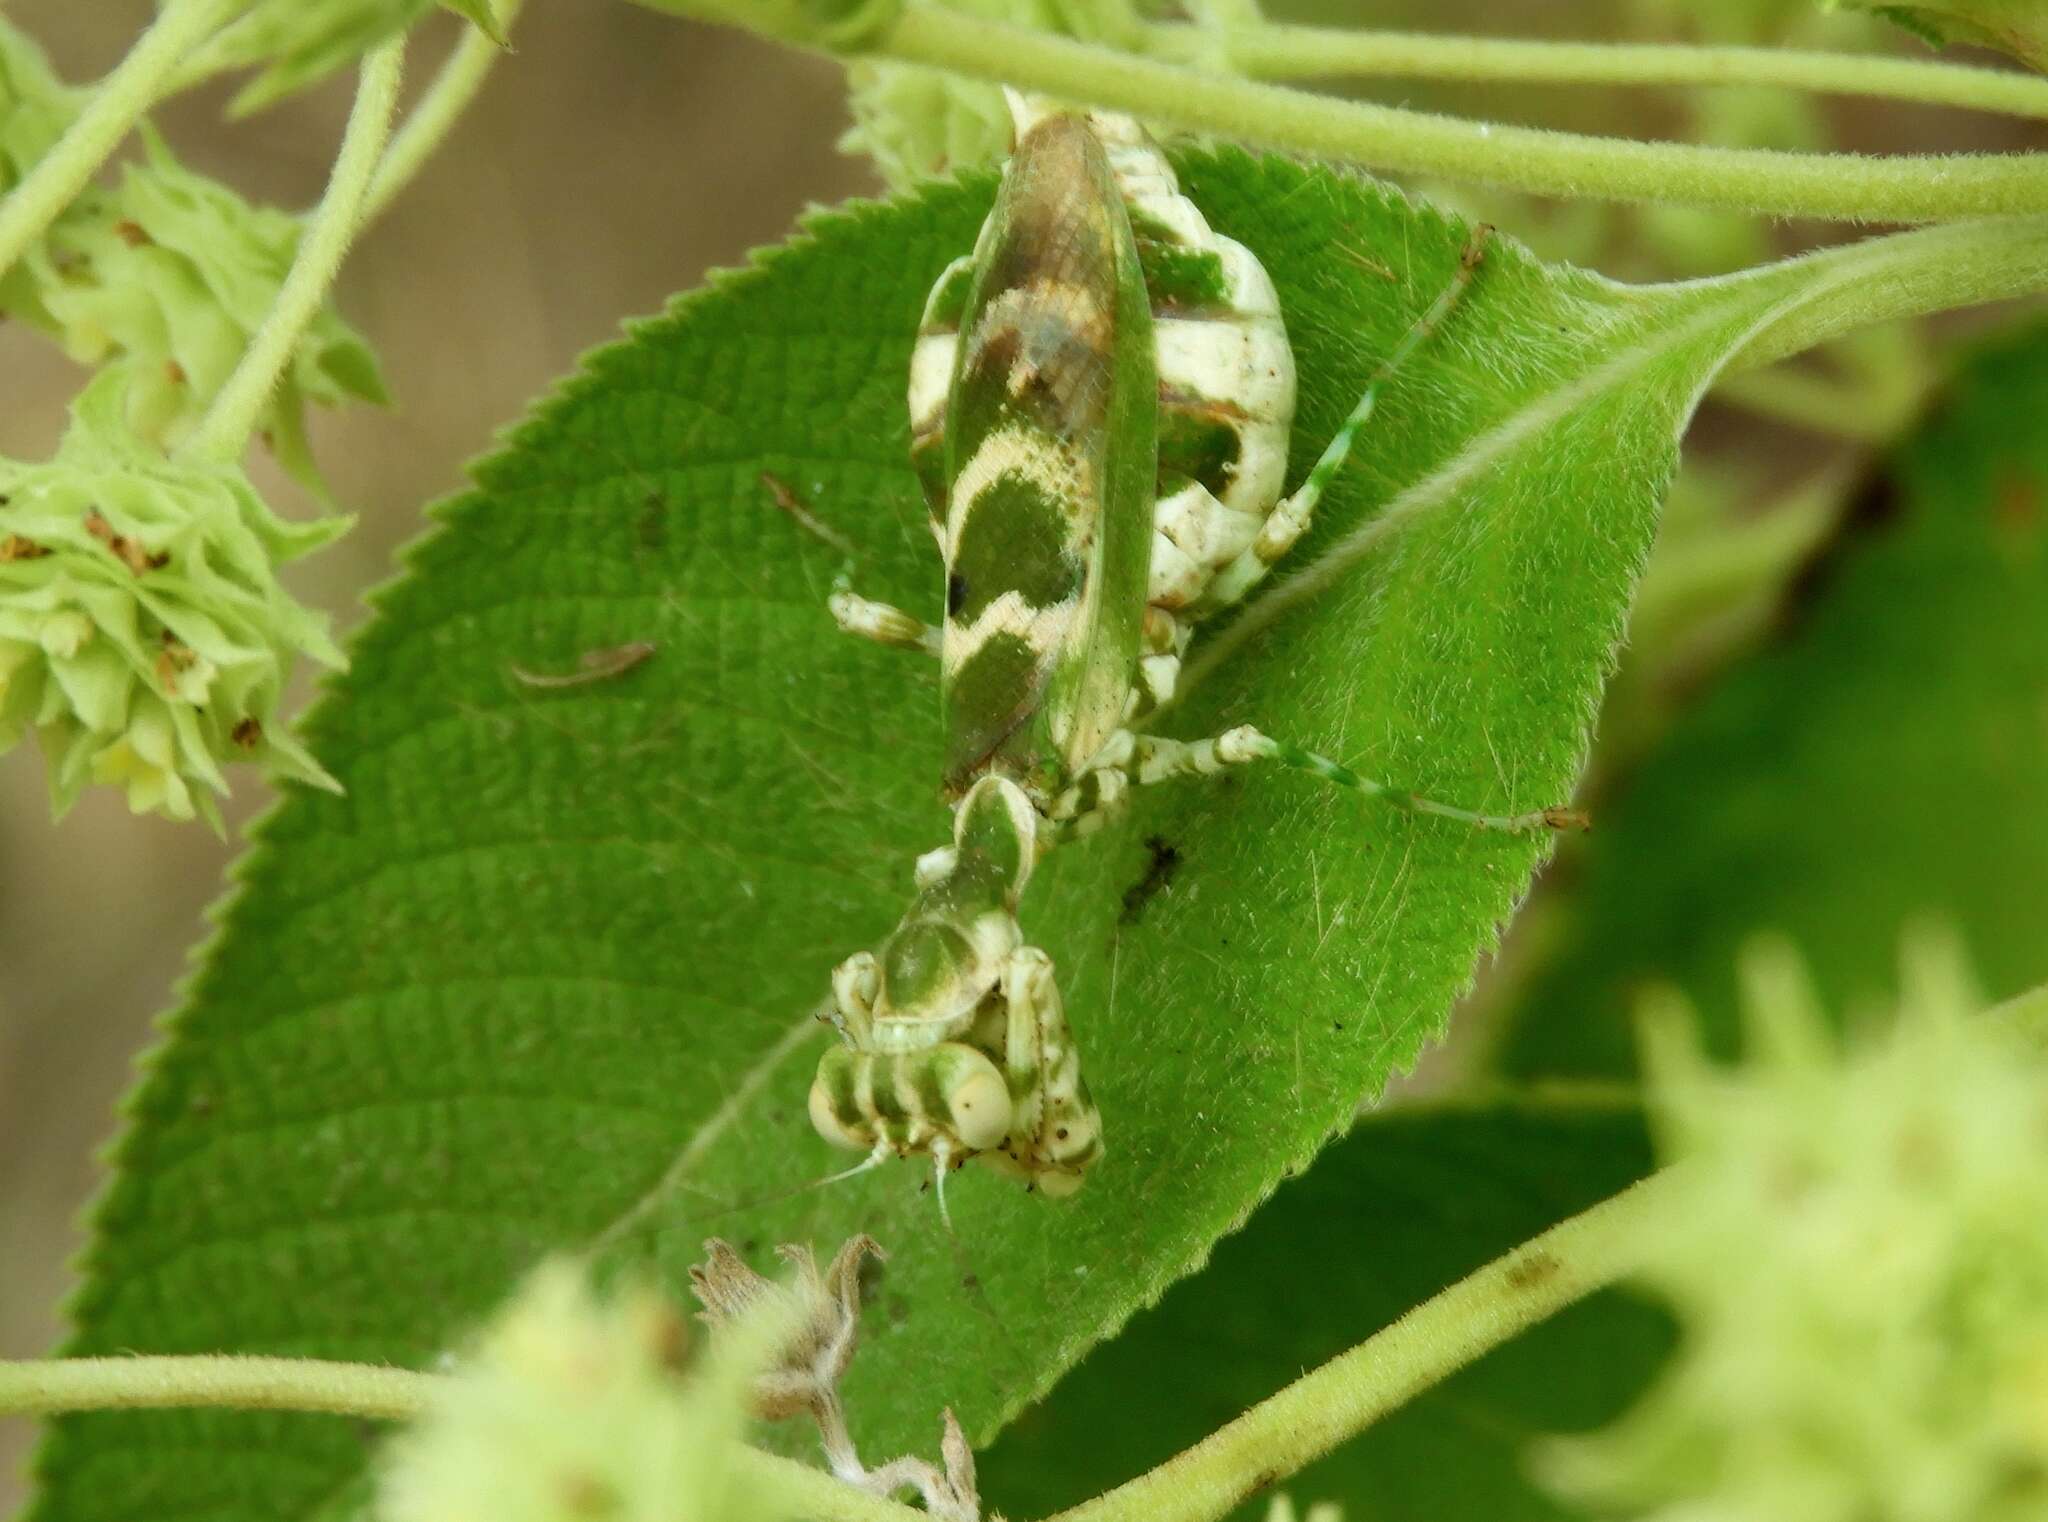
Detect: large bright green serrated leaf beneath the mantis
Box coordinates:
(35, 152, 1982, 1522)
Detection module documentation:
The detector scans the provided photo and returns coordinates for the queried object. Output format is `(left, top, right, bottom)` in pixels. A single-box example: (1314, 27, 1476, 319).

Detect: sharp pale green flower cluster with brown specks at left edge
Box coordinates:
(0, 369, 348, 828)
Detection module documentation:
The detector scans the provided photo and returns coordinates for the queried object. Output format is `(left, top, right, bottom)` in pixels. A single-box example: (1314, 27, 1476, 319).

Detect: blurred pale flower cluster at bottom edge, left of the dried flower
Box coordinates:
(377, 1264, 780, 1522)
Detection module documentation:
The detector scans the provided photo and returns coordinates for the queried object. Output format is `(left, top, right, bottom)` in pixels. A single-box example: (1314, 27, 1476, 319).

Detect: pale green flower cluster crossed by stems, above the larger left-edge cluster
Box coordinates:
(0, 20, 387, 483)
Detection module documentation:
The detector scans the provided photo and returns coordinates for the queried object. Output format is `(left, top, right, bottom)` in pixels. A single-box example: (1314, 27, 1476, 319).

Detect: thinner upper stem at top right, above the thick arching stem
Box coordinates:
(1141, 23, 2048, 119)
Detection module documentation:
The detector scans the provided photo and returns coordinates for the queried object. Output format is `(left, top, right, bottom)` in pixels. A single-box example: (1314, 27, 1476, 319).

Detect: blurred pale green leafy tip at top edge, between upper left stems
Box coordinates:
(178, 0, 502, 117)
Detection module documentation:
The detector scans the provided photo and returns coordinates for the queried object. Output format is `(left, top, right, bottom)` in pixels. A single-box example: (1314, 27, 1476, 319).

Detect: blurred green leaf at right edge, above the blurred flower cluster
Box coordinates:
(1503, 328, 2048, 1075)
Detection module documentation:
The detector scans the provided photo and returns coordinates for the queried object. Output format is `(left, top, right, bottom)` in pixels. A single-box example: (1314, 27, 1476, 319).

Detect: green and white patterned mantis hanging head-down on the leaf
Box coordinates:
(811, 100, 1571, 1200)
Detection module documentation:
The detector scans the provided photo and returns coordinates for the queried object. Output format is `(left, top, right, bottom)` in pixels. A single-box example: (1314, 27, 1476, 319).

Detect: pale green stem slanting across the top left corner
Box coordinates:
(0, 0, 248, 274)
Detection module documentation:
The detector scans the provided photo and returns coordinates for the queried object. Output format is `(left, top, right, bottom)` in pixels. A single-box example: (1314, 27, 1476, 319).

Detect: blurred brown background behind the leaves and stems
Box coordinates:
(0, 0, 2042, 1514)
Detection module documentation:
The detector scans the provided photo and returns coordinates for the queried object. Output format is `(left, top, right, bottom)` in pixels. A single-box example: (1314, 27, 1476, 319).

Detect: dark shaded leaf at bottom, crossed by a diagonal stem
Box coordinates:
(981, 1100, 1671, 1522)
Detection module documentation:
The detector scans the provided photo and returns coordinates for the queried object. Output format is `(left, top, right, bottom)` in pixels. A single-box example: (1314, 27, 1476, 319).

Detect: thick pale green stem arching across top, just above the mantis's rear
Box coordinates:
(641, 0, 2048, 221)
